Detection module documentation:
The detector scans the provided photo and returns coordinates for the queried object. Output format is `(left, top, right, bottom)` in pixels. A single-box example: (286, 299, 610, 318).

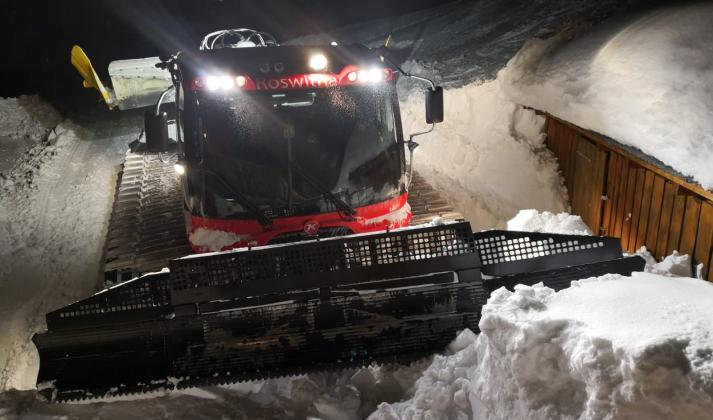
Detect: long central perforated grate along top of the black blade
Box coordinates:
(171, 223, 480, 304)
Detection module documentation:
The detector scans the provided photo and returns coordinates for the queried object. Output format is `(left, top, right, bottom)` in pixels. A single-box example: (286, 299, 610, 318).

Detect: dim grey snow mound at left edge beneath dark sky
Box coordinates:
(0, 95, 62, 140)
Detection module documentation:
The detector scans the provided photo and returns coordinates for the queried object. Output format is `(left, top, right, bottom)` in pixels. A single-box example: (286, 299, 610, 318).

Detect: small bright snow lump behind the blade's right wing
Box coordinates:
(508, 210, 592, 235)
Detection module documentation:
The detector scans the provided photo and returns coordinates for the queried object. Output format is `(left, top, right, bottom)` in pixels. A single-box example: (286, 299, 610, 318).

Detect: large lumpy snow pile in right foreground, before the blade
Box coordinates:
(370, 273, 713, 419)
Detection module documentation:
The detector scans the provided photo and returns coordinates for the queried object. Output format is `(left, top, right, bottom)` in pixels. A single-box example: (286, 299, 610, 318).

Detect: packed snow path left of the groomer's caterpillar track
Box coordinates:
(0, 114, 135, 390)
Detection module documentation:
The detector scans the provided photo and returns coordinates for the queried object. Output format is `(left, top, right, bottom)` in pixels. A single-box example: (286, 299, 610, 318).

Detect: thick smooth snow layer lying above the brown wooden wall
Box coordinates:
(498, 2, 713, 189)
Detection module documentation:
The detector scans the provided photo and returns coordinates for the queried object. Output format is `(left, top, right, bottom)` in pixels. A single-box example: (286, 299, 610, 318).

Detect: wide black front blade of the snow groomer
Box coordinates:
(33, 222, 644, 401)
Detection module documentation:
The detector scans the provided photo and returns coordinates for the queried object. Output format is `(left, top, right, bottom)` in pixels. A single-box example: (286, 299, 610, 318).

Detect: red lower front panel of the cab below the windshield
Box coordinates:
(188, 194, 411, 252)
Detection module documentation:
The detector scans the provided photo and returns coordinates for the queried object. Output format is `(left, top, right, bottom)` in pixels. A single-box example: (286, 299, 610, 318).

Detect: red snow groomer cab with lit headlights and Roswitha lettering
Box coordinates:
(154, 31, 442, 252)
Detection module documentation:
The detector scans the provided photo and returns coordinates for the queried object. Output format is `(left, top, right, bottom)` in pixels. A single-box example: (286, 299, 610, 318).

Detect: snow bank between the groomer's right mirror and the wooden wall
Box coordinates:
(401, 79, 568, 229)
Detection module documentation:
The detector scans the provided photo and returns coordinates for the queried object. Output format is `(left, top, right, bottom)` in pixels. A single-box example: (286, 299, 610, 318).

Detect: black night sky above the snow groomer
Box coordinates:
(0, 0, 456, 108)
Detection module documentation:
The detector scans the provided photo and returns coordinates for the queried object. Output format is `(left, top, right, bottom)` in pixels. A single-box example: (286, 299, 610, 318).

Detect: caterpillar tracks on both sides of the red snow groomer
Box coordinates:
(104, 150, 463, 284)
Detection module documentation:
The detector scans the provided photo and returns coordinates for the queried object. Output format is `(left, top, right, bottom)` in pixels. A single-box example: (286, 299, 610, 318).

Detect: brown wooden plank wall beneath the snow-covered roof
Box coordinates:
(547, 115, 713, 281)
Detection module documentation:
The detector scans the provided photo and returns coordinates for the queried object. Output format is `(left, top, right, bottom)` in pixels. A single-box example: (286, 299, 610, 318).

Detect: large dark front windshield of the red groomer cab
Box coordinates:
(193, 85, 403, 217)
